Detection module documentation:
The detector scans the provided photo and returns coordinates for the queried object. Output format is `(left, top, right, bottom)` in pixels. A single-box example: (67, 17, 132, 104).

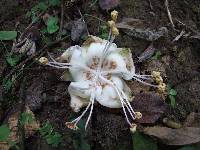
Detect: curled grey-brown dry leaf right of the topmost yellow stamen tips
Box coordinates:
(117, 18, 168, 41)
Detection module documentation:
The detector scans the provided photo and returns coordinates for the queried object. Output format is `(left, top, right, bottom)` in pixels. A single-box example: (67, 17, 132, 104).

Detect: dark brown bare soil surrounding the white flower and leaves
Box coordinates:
(0, 0, 200, 150)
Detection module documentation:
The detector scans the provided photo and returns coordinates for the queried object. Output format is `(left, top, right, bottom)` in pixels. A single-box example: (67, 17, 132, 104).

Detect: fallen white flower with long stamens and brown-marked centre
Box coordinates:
(39, 10, 164, 130)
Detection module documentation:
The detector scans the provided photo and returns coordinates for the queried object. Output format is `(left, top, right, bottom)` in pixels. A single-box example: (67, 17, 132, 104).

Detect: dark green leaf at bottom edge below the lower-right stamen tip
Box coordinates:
(132, 131, 158, 150)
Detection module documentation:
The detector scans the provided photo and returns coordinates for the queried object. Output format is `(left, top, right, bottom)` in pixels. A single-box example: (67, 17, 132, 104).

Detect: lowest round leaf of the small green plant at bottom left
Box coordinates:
(46, 132, 62, 147)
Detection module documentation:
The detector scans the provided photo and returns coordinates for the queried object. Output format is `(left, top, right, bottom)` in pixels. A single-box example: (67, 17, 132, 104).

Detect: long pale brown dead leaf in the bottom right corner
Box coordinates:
(143, 126, 200, 145)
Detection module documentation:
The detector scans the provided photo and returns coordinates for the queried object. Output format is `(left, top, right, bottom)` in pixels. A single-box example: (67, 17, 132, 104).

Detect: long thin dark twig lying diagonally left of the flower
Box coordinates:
(5, 36, 69, 80)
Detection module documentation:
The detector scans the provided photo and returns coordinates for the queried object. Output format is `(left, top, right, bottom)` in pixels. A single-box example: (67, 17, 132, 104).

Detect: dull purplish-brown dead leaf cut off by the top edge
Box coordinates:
(99, 0, 119, 10)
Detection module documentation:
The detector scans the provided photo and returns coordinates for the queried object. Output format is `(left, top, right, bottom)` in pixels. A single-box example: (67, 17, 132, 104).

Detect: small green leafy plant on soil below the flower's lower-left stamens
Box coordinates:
(39, 122, 62, 147)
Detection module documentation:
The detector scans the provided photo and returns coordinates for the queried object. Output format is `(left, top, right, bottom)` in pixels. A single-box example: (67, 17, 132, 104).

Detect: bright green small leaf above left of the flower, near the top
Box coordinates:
(47, 17, 59, 34)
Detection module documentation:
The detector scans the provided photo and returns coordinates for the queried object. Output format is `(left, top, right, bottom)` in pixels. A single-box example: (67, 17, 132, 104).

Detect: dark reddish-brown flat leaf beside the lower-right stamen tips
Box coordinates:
(131, 93, 166, 123)
